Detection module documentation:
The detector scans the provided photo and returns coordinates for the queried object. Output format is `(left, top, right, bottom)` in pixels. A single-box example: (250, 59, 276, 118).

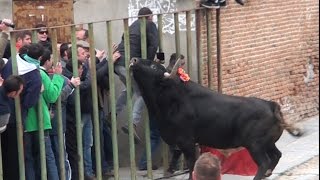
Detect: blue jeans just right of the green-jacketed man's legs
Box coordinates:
(50, 134, 71, 180)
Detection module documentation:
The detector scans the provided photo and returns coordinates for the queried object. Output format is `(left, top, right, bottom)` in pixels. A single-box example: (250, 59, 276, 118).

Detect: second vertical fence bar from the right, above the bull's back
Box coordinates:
(206, 9, 213, 89)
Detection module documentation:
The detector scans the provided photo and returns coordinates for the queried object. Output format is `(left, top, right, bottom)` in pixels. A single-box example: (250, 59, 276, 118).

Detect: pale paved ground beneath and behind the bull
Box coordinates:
(109, 116, 319, 180)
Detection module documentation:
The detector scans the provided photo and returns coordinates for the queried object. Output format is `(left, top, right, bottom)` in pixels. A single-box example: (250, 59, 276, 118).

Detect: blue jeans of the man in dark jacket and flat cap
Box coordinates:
(81, 114, 93, 176)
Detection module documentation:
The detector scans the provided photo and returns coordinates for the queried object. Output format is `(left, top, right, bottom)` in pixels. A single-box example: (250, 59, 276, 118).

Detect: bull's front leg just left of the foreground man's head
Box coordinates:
(177, 141, 196, 180)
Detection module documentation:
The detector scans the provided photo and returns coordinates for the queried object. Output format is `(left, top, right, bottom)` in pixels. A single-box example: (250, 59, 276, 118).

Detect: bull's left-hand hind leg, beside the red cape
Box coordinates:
(248, 144, 271, 180)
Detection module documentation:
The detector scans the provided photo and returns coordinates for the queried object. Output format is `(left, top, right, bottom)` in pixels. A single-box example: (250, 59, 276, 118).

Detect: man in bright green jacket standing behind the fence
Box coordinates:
(24, 45, 64, 180)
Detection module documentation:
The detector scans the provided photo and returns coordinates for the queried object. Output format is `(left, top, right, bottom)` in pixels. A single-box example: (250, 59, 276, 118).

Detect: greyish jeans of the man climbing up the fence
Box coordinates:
(114, 65, 144, 124)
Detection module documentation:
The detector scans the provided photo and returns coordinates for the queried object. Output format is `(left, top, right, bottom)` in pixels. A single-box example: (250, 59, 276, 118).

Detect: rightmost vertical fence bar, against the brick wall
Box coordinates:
(216, 9, 223, 93)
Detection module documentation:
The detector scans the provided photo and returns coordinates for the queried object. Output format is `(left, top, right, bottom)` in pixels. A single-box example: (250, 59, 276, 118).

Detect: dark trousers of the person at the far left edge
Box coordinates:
(1, 124, 20, 180)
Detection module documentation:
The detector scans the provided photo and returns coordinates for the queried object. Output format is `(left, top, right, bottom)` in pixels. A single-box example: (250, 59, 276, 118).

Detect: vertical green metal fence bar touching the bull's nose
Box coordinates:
(123, 19, 137, 180)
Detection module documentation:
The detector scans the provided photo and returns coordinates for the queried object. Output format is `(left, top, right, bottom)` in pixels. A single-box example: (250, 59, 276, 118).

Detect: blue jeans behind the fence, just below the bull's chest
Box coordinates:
(139, 115, 161, 169)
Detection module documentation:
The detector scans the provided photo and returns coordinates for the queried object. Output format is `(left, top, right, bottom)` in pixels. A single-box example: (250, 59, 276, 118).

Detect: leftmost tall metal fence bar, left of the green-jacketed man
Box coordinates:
(10, 32, 26, 180)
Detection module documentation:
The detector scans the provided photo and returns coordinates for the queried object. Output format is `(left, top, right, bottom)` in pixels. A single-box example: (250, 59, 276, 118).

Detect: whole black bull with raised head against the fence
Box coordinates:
(130, 58, 301, 180)
